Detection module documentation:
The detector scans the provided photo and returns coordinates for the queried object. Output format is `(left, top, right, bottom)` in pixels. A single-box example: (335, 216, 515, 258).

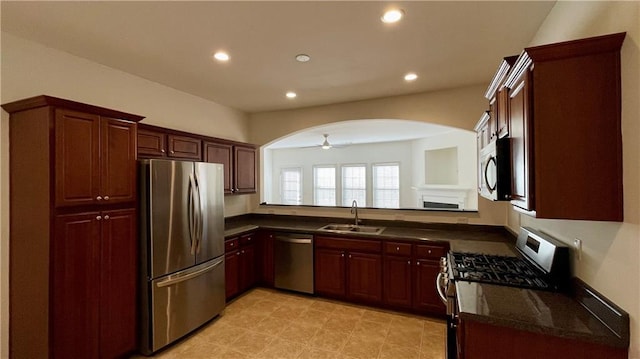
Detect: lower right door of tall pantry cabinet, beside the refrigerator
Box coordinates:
(100, 209, 138, 358)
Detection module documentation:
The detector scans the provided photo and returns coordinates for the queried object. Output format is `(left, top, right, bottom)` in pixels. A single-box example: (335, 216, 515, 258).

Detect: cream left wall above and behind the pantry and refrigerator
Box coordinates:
(0, 32, 255, 358)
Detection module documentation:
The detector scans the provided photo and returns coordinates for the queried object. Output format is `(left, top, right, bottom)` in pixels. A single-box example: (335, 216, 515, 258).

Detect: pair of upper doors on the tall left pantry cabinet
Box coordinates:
(55, 109, 136, 206)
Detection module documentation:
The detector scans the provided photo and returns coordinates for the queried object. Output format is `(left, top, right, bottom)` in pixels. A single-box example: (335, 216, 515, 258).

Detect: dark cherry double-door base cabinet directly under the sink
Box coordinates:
(314, 237, 382, 304)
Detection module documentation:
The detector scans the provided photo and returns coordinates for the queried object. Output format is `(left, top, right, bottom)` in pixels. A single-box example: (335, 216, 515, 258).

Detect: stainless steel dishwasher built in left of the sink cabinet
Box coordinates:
(273, 232, 313, 294)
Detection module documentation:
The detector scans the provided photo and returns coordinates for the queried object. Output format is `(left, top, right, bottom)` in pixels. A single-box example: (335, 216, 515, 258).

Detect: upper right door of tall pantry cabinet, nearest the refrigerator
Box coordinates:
(100, 117, 137, 203)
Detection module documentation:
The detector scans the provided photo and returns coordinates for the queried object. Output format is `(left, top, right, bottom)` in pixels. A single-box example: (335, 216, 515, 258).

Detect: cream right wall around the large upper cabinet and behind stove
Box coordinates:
(508, 1, 640, 359)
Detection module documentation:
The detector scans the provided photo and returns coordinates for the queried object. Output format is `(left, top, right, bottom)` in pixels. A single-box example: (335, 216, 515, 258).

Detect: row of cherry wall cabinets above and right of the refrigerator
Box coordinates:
(138, 124, 257, 194)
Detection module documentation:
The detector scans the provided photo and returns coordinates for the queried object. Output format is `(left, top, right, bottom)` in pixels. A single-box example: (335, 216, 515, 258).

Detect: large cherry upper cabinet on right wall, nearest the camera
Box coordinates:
(505, 33, 625, 221)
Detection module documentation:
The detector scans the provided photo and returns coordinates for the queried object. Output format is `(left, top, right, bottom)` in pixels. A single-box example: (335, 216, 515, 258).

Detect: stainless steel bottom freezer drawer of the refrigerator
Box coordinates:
(143, 256, 225, 354)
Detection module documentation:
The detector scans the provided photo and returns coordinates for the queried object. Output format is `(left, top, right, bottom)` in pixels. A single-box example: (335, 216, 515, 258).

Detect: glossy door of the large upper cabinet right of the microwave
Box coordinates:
(508, 71, 535, 211)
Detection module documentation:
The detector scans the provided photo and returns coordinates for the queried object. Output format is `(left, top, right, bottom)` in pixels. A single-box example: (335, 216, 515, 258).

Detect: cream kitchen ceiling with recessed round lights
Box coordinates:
(1, 1, 554, 114)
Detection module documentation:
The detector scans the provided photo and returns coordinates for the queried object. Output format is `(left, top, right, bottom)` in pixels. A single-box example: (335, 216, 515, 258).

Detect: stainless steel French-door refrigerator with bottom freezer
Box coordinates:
(139, 160, 225, 355)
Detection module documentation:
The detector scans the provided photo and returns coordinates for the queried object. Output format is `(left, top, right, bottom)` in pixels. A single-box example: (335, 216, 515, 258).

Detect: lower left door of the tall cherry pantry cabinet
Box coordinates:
(52, 212, 101, 358)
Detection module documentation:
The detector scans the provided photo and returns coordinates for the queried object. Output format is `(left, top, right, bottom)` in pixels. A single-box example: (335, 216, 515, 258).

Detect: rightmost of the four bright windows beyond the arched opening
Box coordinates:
(372, 163, 400, 208)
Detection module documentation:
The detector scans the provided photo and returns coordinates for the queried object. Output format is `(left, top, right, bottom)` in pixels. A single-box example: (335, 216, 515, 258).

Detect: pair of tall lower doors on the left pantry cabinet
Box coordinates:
(52, 209, 138, 358)
